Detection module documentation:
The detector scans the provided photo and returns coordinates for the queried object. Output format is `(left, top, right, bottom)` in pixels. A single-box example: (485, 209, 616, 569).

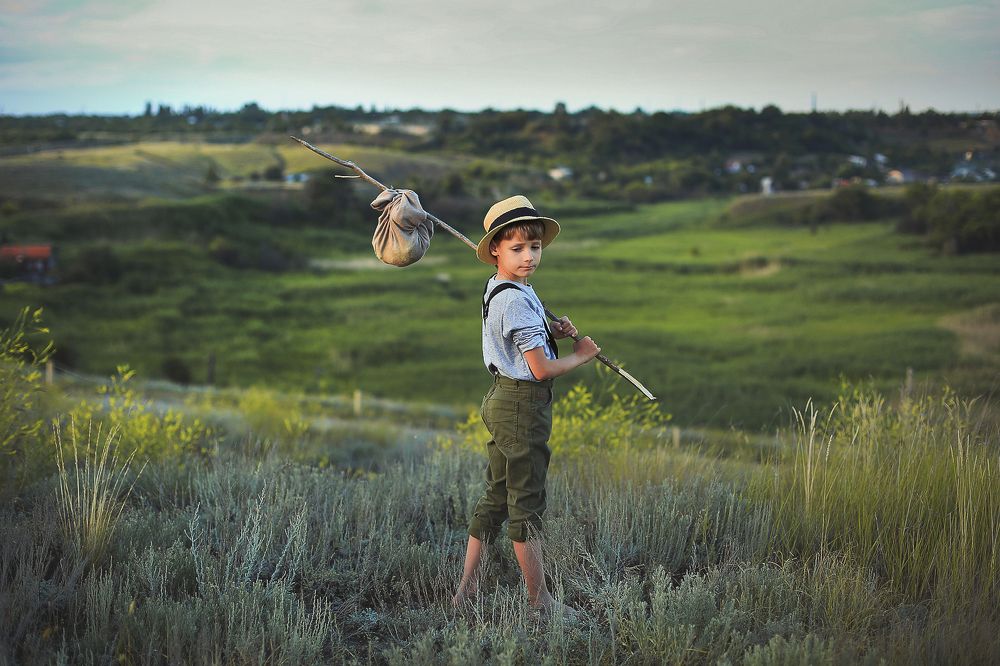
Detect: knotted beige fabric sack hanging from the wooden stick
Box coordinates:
(372, 189, 434, 266)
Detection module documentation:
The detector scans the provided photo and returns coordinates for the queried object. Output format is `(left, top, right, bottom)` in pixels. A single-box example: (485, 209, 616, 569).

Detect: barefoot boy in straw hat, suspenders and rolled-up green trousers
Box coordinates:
(452, 196, 601, 615)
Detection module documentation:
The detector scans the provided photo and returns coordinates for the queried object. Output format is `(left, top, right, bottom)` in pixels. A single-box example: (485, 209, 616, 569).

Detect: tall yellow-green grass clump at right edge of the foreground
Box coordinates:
(758, 393, 1000, 619)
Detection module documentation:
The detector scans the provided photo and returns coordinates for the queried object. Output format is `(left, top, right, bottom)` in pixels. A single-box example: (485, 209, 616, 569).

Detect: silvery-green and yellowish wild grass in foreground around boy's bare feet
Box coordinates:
(0, 368, 1000, 664)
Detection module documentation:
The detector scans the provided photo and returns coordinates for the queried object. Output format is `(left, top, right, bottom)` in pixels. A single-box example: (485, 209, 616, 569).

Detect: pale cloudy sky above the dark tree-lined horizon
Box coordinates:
(0, 0, 1000, 115)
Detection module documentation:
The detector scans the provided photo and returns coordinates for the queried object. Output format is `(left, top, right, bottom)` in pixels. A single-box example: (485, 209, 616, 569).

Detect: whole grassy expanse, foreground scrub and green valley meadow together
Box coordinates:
(0, 144, 1000, 664)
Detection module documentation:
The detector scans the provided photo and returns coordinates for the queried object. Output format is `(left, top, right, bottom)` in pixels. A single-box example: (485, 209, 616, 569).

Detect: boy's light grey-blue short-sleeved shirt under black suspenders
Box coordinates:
(483, 275, 555, 382)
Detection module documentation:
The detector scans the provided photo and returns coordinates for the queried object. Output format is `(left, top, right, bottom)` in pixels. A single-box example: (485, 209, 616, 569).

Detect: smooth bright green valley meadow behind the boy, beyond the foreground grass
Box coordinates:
(0, 144, 1000, 427)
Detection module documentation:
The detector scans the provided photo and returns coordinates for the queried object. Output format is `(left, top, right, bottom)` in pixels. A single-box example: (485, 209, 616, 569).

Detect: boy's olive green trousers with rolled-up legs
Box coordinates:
(469, 375, 552, 543)
